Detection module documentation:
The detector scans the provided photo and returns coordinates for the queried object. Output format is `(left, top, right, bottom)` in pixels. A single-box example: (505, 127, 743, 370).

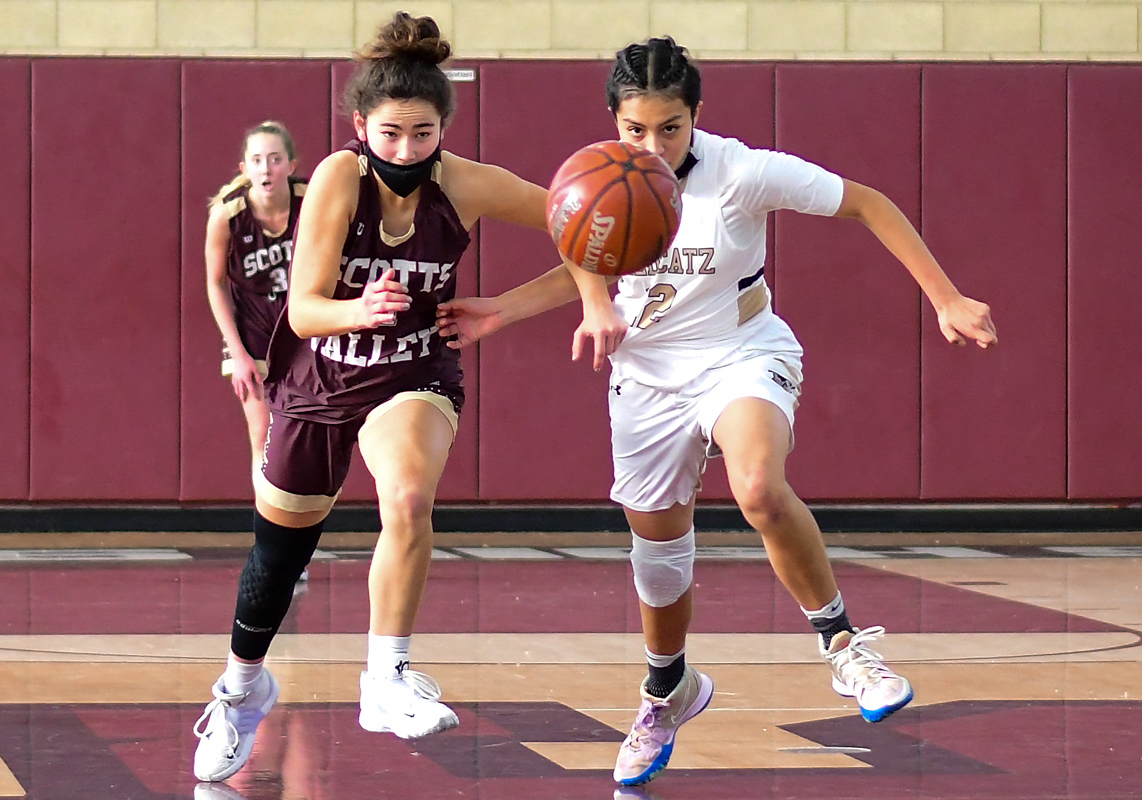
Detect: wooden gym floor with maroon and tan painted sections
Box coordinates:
(0, 533, 1142, 800)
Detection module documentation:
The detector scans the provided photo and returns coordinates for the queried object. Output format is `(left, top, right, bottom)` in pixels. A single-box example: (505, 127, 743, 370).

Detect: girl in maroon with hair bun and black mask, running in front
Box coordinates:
(194, 13, 626, 781)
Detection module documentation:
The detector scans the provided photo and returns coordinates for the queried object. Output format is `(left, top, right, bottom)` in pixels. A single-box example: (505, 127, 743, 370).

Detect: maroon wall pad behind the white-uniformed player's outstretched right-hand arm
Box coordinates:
(774, 64, 920, 500)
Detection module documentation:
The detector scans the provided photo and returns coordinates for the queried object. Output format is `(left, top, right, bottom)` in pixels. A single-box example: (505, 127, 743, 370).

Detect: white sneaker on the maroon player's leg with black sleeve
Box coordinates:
(194, 669, 280, 781)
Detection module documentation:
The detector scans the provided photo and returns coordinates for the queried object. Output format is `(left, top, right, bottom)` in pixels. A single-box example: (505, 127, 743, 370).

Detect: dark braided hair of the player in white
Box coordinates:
(606, 37, 702, 115)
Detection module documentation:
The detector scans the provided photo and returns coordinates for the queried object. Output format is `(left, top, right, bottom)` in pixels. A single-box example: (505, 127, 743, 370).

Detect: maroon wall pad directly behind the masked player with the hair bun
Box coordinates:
(327, 62, 480, 502)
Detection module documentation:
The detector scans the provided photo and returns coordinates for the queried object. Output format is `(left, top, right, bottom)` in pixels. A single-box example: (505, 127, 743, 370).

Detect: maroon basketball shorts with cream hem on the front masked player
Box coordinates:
(254, 389, 460, 512)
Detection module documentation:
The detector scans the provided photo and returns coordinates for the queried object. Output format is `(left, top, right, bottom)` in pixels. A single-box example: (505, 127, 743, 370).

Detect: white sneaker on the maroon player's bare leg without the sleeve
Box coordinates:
(359, 670, 460, 738)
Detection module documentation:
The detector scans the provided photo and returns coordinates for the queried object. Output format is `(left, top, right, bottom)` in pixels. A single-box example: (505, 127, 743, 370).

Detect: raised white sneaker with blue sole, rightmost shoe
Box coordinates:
(817, 625, 912, 722)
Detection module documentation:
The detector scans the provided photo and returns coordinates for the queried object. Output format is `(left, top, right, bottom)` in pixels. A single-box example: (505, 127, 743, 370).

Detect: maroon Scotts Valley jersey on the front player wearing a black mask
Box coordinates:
(266, 140, 469, 422)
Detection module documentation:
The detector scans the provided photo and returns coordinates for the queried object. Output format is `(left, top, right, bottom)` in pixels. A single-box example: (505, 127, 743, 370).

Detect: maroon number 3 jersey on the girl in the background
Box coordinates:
(222, 178, 307, 358)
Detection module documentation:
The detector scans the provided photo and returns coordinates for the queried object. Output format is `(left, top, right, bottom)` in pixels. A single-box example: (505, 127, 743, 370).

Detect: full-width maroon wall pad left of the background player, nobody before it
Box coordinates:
(30, 58, 179, 502)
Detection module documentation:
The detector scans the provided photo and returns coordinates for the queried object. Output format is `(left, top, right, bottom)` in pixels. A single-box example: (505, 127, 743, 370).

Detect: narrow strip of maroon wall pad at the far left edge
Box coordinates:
(0, 59, 32, 500)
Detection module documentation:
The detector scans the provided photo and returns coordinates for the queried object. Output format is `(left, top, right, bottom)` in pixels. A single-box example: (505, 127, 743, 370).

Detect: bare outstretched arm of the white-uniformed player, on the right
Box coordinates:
(836, 180, 999, 348)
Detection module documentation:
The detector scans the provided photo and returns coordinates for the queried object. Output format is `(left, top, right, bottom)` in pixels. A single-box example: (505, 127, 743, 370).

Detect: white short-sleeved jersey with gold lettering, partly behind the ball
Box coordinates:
(611, 130, 844, 389)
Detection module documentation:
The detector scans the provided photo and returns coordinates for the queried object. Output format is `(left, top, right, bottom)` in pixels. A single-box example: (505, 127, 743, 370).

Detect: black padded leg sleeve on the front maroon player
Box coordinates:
(230, 511, 324, 661)
